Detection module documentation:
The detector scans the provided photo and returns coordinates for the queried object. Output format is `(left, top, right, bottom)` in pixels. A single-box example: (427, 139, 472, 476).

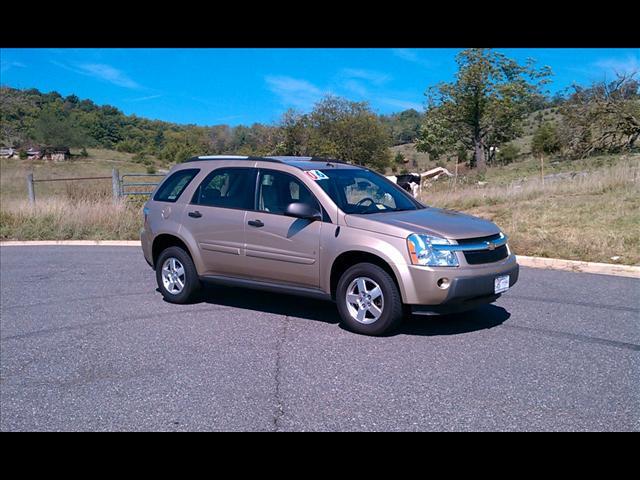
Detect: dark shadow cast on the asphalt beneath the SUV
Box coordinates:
(157, 285, 511, 336)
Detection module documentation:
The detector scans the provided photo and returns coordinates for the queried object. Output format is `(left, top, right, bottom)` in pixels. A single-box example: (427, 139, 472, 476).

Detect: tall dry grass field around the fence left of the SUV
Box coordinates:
(0, 149, 155, 240)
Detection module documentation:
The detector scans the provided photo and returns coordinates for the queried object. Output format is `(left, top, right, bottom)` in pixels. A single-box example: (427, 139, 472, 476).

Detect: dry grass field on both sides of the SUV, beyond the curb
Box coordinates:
(0, 151, 640, 265)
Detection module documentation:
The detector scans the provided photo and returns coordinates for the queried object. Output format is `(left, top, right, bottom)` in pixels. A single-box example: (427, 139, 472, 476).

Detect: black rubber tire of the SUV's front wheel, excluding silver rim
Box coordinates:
(336, 263, 403, 336)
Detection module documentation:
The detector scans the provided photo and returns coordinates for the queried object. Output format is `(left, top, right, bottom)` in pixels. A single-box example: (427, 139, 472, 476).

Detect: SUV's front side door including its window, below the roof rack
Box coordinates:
(245, 170, 323, 287)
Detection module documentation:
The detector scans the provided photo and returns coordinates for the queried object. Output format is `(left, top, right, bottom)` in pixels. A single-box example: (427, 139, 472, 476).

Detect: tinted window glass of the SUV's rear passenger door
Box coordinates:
(191, 168, 256, 210)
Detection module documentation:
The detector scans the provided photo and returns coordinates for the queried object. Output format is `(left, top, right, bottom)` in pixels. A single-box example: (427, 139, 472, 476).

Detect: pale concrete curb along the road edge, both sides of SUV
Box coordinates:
(0, 240, 640, 279)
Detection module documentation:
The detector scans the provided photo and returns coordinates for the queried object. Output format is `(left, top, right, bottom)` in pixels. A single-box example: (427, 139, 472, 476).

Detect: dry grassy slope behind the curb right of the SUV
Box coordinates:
(423, 157, 640, 265)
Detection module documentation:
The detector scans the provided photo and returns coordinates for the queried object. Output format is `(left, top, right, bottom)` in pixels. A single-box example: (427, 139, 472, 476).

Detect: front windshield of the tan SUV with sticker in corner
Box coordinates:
(316, 168, 424, 214)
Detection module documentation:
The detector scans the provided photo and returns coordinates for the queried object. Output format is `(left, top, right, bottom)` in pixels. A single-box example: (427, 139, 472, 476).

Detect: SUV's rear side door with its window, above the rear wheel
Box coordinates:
(183, 167, 256, 276)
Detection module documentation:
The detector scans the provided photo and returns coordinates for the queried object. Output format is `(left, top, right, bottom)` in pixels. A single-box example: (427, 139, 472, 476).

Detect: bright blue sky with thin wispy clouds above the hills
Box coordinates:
(0, 49, 640, 125)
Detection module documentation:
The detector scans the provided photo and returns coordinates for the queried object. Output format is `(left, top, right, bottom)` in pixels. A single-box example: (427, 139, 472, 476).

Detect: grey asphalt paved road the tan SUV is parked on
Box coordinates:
(0, 247, 640, 431)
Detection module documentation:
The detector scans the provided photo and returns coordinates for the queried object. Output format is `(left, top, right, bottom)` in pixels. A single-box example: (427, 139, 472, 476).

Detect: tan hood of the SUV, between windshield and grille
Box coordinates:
(345, 207, 500, 240)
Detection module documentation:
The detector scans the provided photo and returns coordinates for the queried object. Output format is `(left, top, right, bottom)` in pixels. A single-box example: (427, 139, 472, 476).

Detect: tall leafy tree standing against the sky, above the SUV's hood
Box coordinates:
(417, 48, 551, 169)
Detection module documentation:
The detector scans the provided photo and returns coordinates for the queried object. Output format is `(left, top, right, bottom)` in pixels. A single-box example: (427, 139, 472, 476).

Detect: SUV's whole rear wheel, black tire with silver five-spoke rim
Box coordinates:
(156, 247, 200, 303)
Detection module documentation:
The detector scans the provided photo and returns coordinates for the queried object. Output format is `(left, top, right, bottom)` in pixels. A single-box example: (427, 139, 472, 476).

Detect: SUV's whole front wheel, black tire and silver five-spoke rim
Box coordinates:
(336, 263, 403, 335)
